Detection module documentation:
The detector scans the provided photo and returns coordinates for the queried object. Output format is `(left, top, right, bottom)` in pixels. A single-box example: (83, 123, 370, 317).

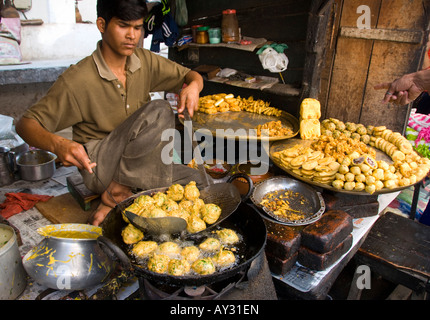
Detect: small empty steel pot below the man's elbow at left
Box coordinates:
(16, 150, 57, 181)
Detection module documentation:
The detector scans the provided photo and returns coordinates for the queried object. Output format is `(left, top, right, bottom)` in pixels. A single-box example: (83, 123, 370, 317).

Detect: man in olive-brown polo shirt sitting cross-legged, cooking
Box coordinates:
(16, 0, 203, 225)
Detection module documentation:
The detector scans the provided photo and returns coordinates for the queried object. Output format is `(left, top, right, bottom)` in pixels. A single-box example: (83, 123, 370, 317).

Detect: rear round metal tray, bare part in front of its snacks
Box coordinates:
(180, 111, 300, 141)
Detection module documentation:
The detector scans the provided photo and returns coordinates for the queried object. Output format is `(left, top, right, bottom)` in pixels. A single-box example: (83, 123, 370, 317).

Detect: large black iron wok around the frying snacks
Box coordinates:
(101, 203, 267, 286)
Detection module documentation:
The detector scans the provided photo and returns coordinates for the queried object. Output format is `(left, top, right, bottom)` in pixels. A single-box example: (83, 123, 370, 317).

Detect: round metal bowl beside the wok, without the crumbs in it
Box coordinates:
(251, 176, 325, 226)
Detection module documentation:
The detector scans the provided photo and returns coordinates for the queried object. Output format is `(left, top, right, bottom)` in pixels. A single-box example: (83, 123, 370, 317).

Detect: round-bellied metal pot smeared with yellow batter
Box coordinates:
(23, 223, 115, 290)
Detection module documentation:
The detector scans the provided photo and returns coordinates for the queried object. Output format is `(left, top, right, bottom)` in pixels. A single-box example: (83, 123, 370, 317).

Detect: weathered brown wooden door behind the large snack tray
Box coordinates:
(320, 0, 430, 132)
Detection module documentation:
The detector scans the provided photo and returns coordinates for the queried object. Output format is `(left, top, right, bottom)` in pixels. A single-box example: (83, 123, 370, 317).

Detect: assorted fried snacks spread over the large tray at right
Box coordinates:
(273, 118, 430, 194)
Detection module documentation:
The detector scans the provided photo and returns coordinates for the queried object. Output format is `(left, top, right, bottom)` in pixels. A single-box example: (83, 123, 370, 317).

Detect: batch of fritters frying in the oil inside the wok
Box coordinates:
(124, 226, 241, 276)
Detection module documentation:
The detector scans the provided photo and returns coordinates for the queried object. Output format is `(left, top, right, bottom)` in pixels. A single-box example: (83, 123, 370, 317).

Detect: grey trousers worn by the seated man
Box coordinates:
(80, 100, 207, 194)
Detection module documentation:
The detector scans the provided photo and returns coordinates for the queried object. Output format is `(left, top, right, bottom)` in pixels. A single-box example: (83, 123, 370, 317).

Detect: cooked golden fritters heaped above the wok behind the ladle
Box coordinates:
(123, 181, 221, 233)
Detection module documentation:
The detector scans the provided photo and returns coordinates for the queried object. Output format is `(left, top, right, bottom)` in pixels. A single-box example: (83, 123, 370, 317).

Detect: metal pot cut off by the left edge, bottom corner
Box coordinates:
(0, 224, 27, 300)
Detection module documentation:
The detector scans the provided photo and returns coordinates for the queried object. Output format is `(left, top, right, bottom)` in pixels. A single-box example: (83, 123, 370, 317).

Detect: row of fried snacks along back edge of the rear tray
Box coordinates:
(198, 93, 282, 117)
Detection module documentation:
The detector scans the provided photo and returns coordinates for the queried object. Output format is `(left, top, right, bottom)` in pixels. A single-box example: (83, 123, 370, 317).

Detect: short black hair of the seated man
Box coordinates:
(97, 0, 148, 25)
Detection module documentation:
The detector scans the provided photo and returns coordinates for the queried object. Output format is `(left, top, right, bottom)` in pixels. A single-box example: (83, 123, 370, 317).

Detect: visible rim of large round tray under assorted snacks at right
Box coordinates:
(269, 138, 418, 196)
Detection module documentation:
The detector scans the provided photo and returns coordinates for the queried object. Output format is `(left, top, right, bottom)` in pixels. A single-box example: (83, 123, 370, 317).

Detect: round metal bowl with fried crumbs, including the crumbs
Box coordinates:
(251, 176, 325, 226)
